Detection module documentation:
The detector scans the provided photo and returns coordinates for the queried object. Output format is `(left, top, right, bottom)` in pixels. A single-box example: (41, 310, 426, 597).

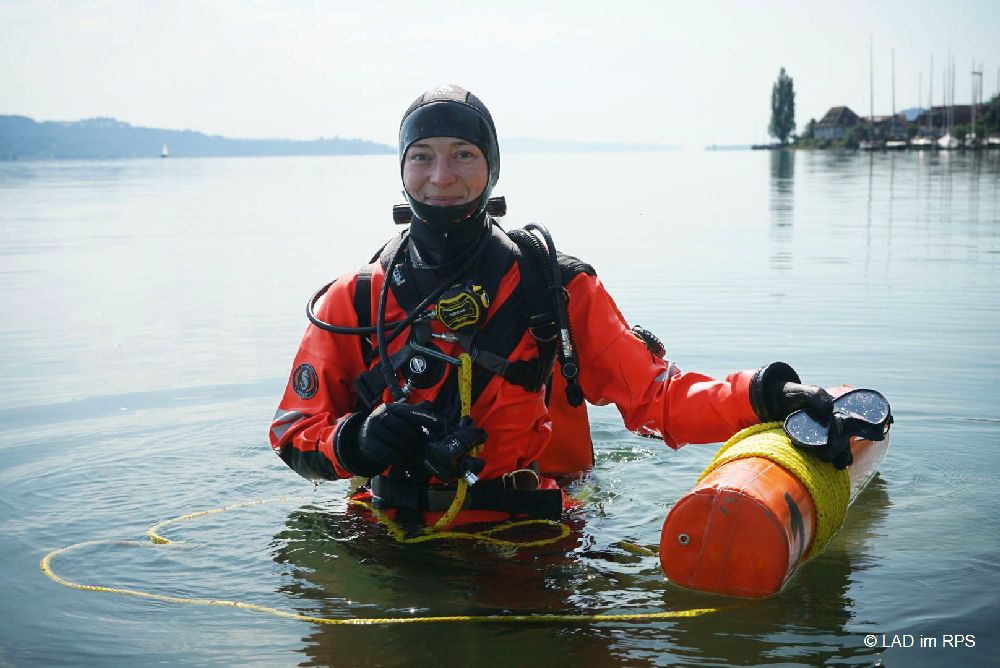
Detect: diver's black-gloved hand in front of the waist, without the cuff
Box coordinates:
(358, 401, 447, 470)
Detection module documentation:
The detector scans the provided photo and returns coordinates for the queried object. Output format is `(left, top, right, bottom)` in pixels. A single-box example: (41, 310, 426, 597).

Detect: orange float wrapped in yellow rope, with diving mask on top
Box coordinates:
(660, 387, 892, 597)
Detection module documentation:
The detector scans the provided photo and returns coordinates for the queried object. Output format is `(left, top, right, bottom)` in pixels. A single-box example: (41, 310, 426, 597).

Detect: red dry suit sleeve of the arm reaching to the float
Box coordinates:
(567, 274, 759, 448)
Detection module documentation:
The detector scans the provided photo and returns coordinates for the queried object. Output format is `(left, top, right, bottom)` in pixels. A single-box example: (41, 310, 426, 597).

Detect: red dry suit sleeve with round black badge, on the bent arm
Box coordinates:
(269, 275, 364, 480)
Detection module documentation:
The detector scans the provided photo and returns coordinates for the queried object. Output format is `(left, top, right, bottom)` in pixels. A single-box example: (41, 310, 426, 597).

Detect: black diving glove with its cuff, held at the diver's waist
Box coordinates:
(334, 401, 447, 478)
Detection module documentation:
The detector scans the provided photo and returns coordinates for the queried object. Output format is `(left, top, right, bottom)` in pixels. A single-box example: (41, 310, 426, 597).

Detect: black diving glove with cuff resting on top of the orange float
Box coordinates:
(750, 362, 833, 424)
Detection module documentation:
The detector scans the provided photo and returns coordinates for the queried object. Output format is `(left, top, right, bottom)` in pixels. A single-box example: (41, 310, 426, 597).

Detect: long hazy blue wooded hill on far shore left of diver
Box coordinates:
(0, 115, 396, 160)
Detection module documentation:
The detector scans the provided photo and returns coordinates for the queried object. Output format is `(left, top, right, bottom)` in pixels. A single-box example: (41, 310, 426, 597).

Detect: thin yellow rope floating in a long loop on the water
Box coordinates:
(39, 497, 747, 626)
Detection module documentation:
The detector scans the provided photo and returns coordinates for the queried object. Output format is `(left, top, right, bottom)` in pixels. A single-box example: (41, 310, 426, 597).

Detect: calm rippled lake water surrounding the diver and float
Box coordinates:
(0, 151, 1000, 666)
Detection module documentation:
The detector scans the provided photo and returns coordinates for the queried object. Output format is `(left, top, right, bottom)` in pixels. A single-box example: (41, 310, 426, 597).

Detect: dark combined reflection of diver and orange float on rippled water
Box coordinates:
(258, 477, 889, 665)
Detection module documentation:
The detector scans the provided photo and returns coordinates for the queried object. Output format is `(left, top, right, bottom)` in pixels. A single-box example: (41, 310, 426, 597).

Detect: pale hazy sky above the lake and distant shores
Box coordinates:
(0, 0, 1000, 146)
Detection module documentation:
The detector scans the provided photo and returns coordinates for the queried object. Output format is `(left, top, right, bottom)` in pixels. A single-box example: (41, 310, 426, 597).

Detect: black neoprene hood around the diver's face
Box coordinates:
(399, 84, 500, 226)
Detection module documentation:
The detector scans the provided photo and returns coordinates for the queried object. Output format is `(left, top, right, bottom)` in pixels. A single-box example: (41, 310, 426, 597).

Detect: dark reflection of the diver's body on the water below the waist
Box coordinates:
(273, 508, 624, 665)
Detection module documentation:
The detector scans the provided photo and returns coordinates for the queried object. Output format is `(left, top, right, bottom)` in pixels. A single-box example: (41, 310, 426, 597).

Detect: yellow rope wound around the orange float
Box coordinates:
(698, 422, 851, 559)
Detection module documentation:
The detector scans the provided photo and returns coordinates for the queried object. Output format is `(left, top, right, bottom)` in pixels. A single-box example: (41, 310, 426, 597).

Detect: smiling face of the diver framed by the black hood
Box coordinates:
(403, 137, 489, 206)
